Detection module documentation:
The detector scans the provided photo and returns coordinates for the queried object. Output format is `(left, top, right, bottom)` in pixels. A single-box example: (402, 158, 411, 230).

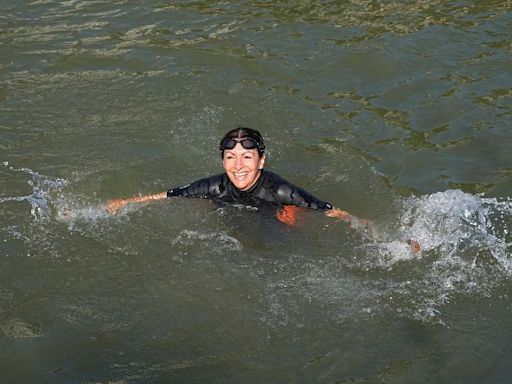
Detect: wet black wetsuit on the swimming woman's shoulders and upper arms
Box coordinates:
(167, 170, 332, 211)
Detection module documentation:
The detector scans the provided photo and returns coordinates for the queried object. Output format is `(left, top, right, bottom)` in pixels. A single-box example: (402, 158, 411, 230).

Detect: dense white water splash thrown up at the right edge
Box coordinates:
(401, 190, 512, 268)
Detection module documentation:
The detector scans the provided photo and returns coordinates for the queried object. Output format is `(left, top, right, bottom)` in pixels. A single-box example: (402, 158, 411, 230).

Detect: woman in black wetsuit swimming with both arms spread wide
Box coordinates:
(107, 127, 368, 226)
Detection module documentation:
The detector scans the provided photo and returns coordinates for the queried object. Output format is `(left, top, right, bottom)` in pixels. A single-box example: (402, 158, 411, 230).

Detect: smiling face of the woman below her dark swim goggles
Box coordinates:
(222, 143, 265, 191)
